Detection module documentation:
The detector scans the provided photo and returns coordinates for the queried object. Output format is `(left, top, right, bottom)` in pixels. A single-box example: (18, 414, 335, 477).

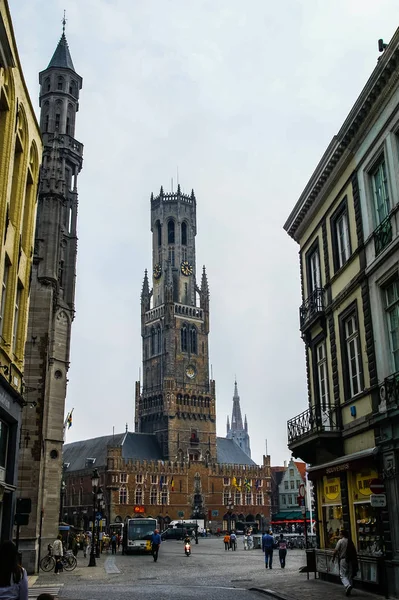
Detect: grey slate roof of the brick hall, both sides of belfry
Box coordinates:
(63, 433, 256, 472)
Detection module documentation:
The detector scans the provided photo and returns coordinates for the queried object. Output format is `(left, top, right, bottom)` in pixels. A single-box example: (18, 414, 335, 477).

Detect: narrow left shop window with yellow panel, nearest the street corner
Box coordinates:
(322, 477, 343, 548)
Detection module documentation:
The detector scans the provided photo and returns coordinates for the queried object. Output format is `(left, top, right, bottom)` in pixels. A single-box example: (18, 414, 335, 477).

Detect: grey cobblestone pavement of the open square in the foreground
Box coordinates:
(32, 538, 388, 600)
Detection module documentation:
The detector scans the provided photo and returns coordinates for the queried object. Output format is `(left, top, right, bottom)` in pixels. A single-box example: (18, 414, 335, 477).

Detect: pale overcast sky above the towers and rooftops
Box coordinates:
(9, 0, 399, 465)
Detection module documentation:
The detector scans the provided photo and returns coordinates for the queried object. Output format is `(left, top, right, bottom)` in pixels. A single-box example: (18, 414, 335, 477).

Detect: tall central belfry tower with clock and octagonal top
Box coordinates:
(135, 186, 216, 462)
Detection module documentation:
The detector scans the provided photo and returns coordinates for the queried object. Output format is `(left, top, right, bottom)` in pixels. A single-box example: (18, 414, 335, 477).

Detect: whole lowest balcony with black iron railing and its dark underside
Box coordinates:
(287, 405, 341, 462)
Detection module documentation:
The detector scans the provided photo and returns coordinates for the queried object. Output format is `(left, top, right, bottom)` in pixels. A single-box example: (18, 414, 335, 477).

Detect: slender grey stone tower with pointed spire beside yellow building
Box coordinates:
(18, 19, 83, 572)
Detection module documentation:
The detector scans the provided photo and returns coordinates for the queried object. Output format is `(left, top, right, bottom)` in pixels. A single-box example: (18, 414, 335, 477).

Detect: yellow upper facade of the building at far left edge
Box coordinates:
(0, 0, 42, 392)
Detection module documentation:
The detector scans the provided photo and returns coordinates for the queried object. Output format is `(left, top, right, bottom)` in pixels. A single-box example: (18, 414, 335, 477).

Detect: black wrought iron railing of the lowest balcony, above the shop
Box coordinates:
(287, 405, 340, 444)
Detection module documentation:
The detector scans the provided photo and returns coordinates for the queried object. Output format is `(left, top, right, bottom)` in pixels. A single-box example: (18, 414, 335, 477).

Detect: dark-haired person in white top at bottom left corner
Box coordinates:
(0, 541, 28, 600)
